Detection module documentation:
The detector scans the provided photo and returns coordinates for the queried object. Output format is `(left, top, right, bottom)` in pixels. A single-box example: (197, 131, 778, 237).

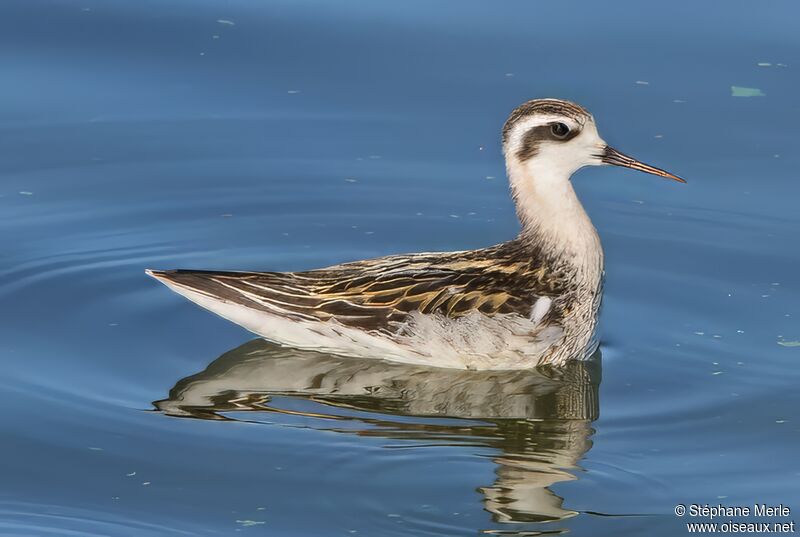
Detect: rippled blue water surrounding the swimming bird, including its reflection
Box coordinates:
(0, 0, 800, 536)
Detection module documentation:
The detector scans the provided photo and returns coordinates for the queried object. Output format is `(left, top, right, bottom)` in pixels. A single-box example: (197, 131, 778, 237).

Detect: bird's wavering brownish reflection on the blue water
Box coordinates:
(153, 340, 600, 522)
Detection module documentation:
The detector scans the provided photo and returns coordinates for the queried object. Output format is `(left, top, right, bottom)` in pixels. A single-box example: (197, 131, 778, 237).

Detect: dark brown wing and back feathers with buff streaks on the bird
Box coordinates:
(153, 241, 558, 330)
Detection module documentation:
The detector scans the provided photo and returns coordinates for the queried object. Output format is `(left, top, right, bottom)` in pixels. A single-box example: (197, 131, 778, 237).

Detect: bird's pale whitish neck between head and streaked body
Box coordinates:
(507, 158, 603, 278)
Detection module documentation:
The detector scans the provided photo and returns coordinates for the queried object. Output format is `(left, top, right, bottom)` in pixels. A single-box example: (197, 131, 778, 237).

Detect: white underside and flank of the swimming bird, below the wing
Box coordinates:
(153, 279, 563, 369)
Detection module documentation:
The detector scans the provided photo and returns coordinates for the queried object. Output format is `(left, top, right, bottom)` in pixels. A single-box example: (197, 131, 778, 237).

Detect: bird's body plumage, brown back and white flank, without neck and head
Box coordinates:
(151, 239, 570, 369)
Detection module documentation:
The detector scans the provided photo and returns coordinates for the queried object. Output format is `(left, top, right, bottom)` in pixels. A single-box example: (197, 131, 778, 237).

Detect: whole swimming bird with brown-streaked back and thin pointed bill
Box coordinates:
(146, 98, 686, 370)
